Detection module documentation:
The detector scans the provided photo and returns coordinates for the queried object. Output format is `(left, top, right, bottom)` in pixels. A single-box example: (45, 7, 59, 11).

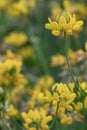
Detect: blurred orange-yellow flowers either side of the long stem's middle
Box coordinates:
(51, 49, 87, 67)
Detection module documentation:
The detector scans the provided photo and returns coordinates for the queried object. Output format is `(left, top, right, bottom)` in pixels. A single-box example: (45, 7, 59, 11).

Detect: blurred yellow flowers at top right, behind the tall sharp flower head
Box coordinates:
(51, 0, 87, 19)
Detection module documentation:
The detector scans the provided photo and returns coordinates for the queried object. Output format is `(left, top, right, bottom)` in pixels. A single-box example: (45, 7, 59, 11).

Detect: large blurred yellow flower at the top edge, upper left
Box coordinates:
(7, 0, 36, 16)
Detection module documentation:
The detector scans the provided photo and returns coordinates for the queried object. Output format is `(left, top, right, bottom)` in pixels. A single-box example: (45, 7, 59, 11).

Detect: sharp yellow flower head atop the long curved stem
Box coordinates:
(45, 12, 83, 36)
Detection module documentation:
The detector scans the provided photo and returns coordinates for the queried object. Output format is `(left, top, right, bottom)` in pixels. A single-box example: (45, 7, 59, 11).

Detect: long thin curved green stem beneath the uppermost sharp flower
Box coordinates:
(64, 33, 81, 93)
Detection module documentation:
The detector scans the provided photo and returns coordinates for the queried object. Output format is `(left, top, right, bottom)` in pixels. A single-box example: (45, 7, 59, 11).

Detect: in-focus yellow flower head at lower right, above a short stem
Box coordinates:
(44, 83, 76, 106)
